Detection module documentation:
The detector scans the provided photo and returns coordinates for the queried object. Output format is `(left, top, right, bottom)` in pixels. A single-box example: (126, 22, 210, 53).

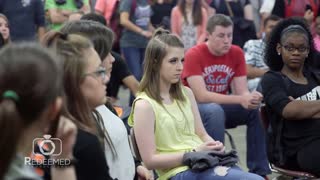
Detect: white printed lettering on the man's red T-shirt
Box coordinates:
(202, 64, 235, 94)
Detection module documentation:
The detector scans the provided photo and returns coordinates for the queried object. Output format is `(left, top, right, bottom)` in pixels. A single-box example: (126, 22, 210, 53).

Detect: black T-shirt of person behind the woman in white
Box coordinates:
(107, 52, 132, 98)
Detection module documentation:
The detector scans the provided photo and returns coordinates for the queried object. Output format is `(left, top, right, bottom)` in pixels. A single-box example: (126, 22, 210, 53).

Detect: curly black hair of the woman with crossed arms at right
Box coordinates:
(264, 17, 316, 71)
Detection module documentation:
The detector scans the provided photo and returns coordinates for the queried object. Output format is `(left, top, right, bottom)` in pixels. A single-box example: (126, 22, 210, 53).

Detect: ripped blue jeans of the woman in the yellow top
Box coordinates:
(170, 166, 263, 180)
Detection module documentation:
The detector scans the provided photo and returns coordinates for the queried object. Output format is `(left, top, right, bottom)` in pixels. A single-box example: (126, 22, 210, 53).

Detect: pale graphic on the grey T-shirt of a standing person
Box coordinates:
(134, 5, 152, 27)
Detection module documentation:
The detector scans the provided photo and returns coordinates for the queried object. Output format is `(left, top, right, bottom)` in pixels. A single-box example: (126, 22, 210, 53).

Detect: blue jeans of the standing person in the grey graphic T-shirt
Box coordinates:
(121, 47, 146, 106)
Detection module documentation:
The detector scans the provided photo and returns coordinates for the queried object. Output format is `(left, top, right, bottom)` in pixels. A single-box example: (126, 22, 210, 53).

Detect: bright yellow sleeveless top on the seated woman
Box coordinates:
(128, 89, 203, 180)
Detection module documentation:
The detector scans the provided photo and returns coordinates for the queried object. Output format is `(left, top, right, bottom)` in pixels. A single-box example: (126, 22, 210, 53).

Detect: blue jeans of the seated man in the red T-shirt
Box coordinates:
(198, 103, 271, 176)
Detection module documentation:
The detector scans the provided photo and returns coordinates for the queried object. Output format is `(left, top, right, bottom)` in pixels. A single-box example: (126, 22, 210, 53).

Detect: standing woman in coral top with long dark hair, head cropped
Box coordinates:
(171, 0, 208, 50)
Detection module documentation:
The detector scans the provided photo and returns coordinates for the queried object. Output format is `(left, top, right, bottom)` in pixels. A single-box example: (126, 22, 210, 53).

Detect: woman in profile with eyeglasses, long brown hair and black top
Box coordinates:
(44, 31, 112, 180)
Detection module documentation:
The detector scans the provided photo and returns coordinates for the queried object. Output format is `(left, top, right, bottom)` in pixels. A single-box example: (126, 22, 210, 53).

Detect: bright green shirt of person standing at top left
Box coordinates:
(45, 0, 89, 30)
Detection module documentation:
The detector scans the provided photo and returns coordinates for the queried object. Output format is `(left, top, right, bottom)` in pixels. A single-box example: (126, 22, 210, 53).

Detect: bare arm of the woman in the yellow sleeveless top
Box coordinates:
(133, 100, 184, 169)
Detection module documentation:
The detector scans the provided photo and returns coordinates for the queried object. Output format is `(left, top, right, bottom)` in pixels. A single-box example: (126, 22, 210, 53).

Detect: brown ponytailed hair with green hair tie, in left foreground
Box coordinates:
(0, 43, 62, 179)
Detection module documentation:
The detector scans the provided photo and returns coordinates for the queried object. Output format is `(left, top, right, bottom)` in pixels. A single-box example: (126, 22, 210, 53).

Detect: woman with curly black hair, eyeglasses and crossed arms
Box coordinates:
(261, 18, 320, 177)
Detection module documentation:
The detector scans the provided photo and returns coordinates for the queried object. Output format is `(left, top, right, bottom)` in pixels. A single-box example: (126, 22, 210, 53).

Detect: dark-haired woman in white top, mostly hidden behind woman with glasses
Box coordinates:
(61, 20, 152, 180)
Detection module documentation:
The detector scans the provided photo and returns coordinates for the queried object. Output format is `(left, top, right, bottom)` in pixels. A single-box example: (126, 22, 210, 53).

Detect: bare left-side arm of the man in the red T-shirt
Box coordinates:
(187, 75, 242, 104)
